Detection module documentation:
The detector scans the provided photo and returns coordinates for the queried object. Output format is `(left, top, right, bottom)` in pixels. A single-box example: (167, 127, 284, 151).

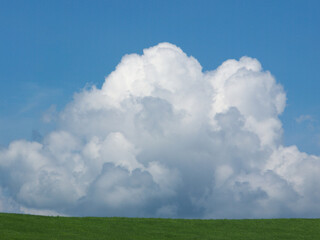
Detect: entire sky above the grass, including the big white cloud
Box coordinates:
(0, 0, 320, 218)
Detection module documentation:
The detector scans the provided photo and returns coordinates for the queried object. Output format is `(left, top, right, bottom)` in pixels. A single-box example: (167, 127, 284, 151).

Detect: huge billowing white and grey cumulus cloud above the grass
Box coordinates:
(0, 43, 320, 218)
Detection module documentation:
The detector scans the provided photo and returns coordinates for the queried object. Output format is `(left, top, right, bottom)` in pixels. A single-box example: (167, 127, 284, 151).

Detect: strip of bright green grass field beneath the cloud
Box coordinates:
(0, 213, 320, 240)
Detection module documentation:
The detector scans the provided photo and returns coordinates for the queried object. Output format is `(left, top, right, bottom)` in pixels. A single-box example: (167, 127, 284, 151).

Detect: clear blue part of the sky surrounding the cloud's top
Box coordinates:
(0, 0, 320, 154)
